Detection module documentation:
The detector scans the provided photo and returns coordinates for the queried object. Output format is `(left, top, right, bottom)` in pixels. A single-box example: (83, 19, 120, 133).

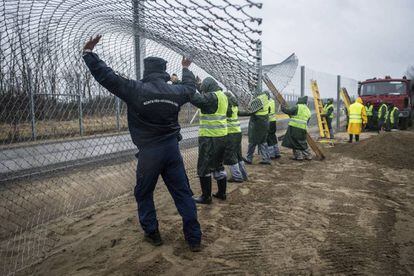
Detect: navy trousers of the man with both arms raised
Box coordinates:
(134, 138, 201, 244)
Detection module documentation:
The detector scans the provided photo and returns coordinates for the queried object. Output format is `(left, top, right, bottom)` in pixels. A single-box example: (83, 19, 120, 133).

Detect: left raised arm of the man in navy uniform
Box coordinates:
(83, 35, 141, 102)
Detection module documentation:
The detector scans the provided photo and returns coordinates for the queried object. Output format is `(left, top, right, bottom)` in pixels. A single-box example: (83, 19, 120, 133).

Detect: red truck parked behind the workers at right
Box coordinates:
(358, 76, 414, 129)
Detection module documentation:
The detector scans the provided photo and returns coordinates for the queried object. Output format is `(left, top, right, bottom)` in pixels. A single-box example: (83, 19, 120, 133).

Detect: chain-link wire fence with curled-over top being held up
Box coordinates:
(0, 0, 356, 275)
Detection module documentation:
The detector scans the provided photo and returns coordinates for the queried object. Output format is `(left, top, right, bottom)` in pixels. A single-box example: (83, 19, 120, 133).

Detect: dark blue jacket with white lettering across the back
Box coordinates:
(83, 53, 196, 148)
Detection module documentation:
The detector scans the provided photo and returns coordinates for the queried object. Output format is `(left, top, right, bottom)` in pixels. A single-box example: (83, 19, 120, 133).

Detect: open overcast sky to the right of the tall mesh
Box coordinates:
(260, 0, 414, 80)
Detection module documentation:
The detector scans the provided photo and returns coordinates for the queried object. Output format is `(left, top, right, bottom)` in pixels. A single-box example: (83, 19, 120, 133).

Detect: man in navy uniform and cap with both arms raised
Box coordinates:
(83, 36, 201, 251)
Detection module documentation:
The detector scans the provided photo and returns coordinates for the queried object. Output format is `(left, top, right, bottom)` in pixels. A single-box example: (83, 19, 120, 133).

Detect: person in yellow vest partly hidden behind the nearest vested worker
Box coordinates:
(224, 92, 248, 183)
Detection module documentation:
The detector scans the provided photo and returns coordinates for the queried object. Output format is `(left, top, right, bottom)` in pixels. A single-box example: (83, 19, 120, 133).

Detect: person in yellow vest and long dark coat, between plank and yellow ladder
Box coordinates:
(282, 96, 312, 161)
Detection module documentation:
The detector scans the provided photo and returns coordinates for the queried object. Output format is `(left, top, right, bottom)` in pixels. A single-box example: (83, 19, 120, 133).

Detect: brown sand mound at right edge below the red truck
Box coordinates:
(332, 131, 414, 169)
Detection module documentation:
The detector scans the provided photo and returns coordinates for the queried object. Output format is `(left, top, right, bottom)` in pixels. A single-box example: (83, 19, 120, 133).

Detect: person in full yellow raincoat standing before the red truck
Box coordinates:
(348, 97, 368, 143)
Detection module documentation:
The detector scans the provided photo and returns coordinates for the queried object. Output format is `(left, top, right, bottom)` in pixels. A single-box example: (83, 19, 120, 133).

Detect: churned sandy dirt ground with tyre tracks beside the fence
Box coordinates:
(18, 131, 414, 275)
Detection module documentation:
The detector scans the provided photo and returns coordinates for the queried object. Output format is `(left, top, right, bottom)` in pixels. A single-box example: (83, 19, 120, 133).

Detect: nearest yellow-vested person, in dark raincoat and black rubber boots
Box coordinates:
(191, 77, 229, 204)
